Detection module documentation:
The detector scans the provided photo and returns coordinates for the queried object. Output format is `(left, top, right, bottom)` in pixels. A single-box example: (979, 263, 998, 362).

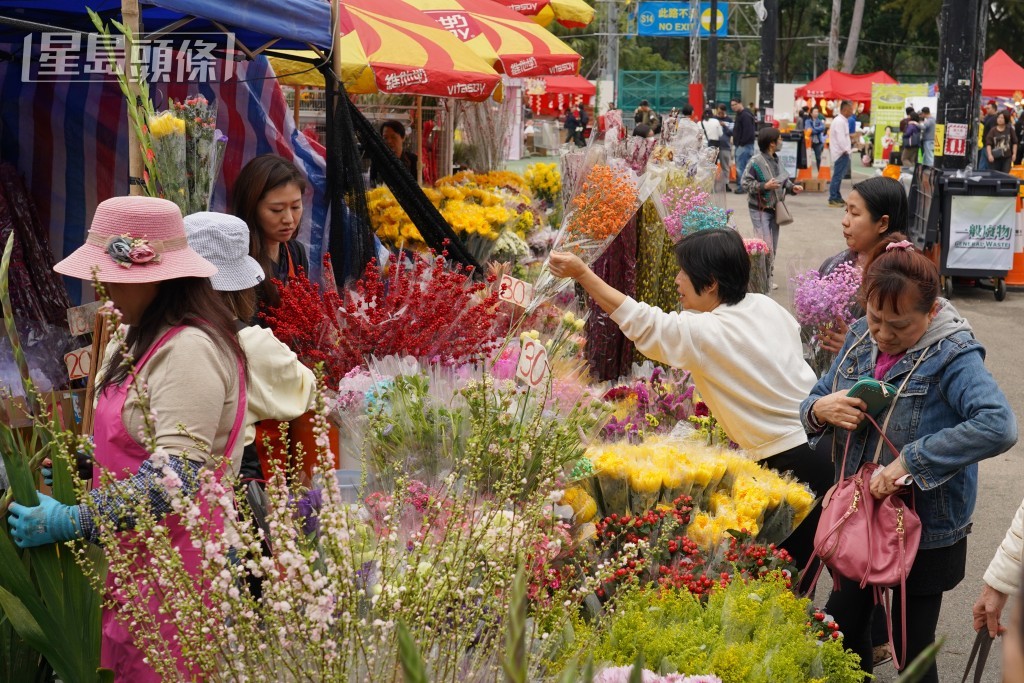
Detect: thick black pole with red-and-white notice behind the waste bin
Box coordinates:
(935, 0, 988, 169)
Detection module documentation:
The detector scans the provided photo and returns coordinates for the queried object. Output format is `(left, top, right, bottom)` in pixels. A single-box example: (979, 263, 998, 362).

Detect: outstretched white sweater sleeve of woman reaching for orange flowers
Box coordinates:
(611, 297, 700, 368)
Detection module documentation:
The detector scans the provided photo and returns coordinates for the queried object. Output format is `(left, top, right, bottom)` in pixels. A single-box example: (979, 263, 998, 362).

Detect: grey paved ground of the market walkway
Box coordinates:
(726, 162, 1024, 682)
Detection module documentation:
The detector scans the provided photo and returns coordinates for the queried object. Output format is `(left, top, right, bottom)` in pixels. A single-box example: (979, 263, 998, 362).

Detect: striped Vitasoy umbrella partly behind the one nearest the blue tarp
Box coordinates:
(406, 0, 580, 78)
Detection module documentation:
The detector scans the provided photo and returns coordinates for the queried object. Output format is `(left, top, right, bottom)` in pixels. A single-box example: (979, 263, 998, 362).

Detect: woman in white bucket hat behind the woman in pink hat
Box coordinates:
(185, 211, 314, 481)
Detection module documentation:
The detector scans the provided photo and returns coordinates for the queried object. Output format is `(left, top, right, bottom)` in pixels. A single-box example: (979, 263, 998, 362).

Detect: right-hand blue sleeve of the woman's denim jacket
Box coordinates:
(901, 347, 1017, 490)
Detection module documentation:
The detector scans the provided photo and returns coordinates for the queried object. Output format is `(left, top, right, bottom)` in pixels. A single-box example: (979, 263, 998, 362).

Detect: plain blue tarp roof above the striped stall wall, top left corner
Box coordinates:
(0, 0, 331, 49)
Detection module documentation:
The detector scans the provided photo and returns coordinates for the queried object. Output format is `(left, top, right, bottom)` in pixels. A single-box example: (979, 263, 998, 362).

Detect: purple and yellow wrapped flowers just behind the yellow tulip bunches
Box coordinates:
(601, 368, 694, 441)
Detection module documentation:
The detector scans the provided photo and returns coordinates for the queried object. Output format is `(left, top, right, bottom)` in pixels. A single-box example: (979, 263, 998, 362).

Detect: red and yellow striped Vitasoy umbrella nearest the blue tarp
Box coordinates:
(339, 0, 501, 101)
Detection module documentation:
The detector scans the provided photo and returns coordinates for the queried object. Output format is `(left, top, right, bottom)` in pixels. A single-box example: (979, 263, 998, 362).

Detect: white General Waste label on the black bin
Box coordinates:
(946, 197, 1017, 271)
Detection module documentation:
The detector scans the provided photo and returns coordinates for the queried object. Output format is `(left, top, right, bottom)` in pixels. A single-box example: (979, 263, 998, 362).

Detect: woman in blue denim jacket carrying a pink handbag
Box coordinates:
(801, 234, 1017, 682)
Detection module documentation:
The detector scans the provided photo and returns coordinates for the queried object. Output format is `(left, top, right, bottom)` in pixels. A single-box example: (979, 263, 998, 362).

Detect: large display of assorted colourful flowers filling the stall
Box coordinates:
(0, 81, 880, 683)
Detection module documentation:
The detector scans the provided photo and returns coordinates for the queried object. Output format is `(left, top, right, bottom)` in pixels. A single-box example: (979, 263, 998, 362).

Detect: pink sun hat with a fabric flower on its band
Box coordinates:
(53, 197, 217, 283)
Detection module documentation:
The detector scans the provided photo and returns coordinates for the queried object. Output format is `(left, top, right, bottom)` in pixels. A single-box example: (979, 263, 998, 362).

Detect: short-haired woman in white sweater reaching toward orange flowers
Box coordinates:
(550, 229, 834, 566)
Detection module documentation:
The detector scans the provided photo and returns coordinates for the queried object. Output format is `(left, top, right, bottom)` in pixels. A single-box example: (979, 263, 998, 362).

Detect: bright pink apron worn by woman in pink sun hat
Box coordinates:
(92, 326, 246, 683)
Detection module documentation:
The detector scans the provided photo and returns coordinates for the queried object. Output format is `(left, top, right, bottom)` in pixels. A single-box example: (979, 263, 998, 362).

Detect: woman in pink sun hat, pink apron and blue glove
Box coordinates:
(8, 197, 247, 683)
